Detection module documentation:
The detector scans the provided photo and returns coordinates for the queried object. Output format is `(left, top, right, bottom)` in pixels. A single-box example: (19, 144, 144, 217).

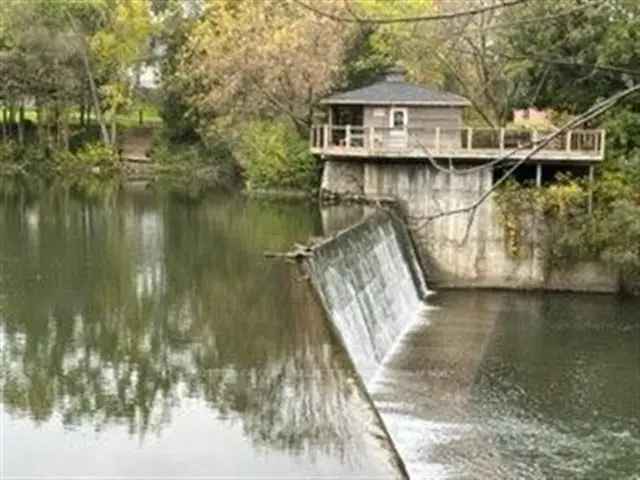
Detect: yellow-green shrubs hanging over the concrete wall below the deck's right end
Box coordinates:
(496, 173, 640, 285)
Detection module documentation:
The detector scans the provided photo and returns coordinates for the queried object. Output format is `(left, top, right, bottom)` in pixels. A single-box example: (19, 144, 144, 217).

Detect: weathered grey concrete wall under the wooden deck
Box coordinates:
(322, 160, 619, 292)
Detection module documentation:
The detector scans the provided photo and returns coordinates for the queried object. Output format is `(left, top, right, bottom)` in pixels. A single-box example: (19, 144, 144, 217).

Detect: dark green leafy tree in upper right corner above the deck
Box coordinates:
(502, 0, 640, 113)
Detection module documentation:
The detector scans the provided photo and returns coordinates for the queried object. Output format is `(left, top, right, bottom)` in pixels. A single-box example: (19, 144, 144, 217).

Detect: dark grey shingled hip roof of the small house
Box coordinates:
(320, 71, 471, 107)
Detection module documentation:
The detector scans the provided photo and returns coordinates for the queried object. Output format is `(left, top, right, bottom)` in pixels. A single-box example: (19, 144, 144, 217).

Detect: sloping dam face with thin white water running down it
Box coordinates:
(307, 211, 427, 476)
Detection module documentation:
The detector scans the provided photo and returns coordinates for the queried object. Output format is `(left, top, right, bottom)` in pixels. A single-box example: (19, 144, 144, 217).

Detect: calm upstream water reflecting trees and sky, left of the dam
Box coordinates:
(0, 190, 395, 476)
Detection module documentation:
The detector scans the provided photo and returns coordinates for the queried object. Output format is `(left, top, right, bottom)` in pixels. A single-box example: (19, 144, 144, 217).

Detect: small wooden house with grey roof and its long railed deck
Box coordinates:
(310, 70, 604, 172)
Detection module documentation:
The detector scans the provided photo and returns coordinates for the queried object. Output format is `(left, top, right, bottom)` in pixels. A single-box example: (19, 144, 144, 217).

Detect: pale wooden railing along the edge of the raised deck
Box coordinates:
(311, 125, 605, 159)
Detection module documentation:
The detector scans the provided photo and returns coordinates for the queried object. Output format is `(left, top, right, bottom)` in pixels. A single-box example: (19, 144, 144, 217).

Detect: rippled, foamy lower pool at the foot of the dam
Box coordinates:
(369, 291, 640, 480)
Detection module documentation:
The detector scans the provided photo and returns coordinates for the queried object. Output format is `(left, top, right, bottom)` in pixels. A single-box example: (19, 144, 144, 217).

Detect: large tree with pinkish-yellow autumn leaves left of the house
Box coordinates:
(178, 0, 357, 132)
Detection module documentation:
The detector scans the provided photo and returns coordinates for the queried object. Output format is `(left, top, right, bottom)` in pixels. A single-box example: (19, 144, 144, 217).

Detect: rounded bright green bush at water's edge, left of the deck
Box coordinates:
(234, 120, 319, 189)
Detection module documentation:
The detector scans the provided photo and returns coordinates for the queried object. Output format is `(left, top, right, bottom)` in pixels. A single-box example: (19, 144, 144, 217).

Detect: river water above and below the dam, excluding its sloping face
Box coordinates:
(0, 188, 640, 479)
